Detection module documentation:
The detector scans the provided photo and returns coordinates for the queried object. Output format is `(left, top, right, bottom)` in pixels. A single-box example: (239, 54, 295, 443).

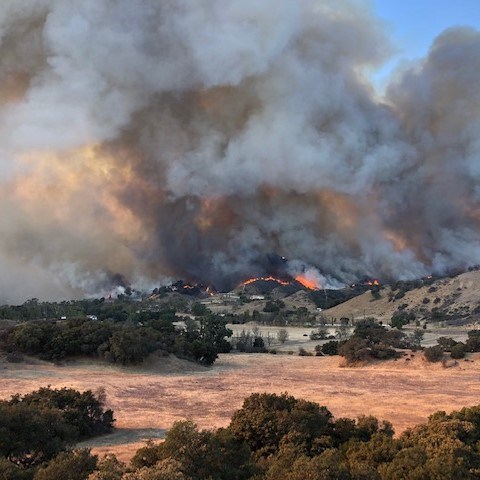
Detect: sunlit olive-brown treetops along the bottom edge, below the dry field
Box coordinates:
(0, 393, 480, 480)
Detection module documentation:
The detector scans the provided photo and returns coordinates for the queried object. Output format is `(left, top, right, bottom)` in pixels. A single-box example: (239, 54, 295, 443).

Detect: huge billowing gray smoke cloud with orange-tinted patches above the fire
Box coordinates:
(0, 0, 480, 301)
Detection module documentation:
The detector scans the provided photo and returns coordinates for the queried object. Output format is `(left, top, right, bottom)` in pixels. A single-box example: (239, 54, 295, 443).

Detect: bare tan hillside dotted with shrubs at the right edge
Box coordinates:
(324, 271, 480, 324)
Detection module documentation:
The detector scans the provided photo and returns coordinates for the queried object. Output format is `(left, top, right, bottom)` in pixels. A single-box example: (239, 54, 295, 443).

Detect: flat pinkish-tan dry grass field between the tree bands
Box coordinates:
(0, 353, 480, 460)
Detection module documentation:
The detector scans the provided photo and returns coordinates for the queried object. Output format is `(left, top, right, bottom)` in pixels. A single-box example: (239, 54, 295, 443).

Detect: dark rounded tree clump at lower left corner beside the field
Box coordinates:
(0, 388, 115, 480)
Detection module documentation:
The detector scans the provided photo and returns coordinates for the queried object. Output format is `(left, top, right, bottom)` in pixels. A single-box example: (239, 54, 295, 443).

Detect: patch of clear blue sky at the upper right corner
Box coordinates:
(371, 0, 480, 87)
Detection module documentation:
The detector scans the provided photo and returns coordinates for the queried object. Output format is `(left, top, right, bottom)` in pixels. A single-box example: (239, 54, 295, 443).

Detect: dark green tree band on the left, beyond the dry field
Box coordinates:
(1, 309, 232, 365)
